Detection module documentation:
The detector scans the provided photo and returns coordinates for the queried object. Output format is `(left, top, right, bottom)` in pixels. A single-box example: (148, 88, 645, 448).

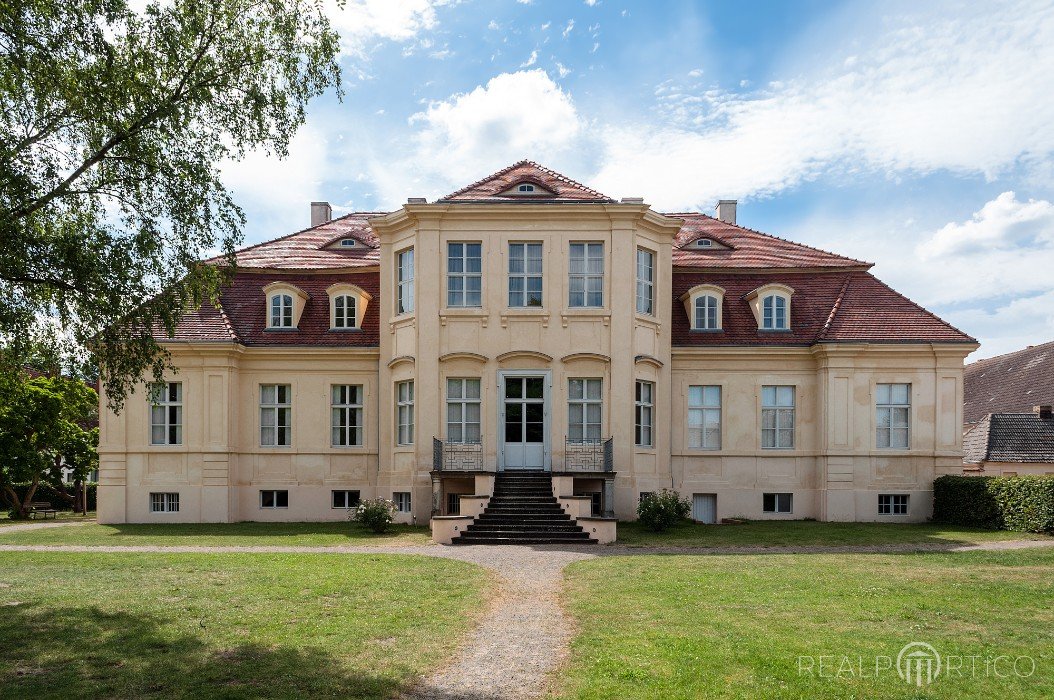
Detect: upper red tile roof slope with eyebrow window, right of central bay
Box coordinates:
(666, 212, 873, 269)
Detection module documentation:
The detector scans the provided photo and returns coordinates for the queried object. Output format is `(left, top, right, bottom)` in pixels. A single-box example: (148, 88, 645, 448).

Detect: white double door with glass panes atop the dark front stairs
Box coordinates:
(502, 374, 547, 469)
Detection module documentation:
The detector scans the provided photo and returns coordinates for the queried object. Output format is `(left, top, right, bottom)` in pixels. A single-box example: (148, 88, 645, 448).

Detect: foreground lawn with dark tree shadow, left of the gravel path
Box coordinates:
(0, 552, 487, 700)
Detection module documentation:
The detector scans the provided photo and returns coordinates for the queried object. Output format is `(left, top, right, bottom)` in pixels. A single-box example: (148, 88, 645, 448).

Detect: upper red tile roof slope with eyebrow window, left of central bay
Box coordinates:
(209, 212, 384, 270)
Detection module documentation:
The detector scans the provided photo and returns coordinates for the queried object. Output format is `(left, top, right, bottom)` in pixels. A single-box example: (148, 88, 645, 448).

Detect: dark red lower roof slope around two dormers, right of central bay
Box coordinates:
(671, 271, 974, 346)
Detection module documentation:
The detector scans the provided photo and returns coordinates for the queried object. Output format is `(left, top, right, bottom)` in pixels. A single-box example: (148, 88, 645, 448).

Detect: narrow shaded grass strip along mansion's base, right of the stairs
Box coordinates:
(619, 520, 1050, 547)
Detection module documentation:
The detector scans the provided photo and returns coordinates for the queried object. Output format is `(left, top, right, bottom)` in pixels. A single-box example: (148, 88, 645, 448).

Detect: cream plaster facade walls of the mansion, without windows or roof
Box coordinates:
(99, 171, 974, 524)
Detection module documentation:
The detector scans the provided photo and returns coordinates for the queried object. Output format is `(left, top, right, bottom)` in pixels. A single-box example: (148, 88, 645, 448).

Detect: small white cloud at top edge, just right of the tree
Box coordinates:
(326, 0, 456, 58)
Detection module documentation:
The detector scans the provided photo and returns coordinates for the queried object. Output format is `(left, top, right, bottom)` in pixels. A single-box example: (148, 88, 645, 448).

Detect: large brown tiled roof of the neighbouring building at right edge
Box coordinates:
(962, 342, 1054, 430)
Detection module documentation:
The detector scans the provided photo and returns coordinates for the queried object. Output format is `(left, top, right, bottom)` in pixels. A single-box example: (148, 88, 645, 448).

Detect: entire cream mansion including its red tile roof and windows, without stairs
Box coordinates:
(98, 161, 977, 523)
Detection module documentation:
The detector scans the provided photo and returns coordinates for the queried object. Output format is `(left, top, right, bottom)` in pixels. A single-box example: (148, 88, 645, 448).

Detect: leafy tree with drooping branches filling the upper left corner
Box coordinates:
(0, 0, 340, 410)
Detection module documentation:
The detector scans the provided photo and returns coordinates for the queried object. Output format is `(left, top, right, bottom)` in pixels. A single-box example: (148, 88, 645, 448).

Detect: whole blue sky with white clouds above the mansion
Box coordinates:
(223, 0, 1054, 358)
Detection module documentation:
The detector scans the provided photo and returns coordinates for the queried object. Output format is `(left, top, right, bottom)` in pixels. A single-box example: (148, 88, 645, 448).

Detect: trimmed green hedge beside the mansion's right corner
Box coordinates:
(933, 477, 1054, 532)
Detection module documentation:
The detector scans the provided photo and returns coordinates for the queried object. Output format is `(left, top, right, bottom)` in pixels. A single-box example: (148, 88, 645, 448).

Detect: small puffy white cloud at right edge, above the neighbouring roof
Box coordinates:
(919, 192, 1054, 259)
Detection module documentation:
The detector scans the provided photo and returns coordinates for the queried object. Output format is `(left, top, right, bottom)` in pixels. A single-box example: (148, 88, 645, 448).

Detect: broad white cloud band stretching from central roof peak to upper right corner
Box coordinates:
(594, 3, 1054, 209)
